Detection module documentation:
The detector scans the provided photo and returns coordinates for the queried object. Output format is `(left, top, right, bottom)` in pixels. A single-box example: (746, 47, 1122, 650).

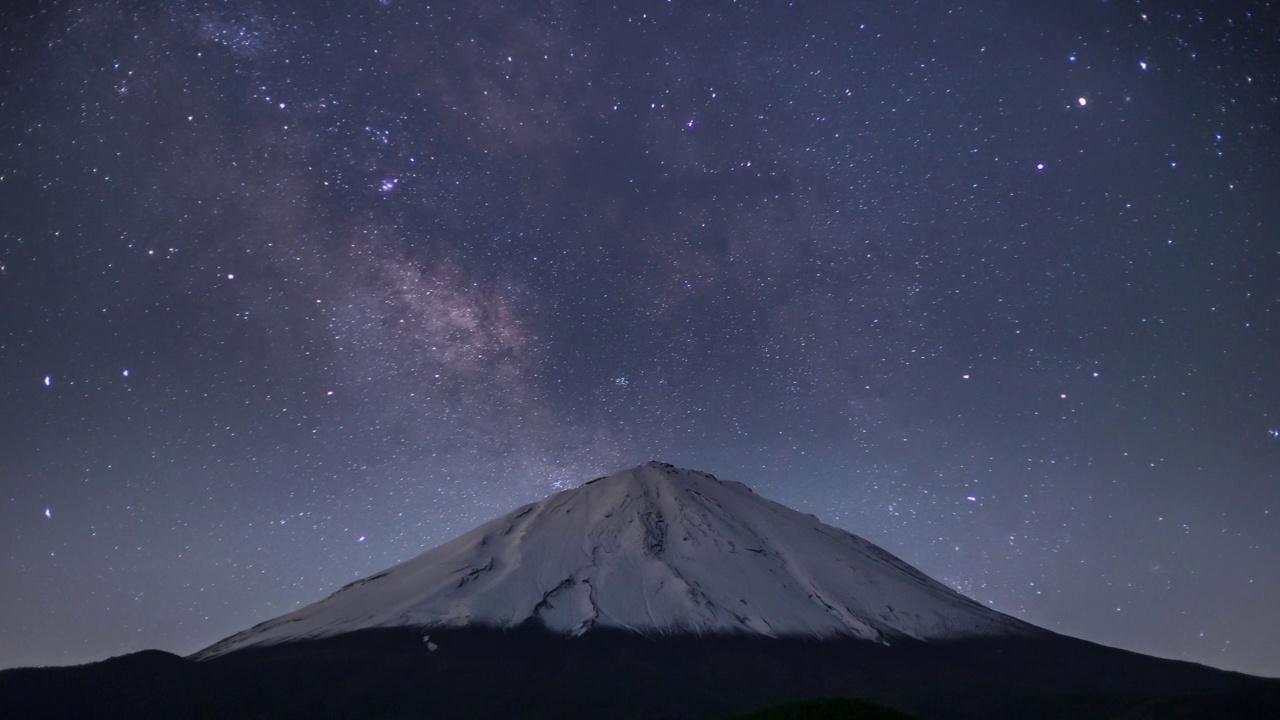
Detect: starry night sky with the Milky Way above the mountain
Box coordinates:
(0, 0, 1280, 675)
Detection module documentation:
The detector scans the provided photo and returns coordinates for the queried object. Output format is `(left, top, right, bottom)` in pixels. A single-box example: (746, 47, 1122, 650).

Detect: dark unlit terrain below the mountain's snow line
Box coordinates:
(0, 628, 1280, 720)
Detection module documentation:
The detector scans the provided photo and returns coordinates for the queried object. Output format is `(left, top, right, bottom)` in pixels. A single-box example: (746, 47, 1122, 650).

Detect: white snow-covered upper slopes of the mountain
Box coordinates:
(197, 462, 1039, 657)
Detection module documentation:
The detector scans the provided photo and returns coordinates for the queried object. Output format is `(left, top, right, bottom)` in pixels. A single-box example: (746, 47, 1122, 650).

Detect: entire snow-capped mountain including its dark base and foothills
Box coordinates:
(0, 462, 1280, 720)
